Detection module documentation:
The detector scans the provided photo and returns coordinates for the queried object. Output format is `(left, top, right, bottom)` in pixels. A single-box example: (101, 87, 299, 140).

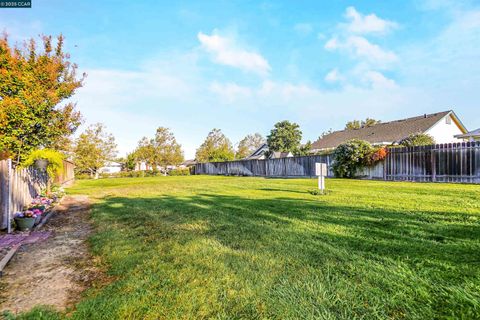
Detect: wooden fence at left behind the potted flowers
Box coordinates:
(0, 159, 74, 231)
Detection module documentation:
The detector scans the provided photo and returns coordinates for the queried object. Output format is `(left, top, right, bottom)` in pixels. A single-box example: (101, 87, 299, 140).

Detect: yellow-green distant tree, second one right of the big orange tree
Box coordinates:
(135, 127, 183, 173)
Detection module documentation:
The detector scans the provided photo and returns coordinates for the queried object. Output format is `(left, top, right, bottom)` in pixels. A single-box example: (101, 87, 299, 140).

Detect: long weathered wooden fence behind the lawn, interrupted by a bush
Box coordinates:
(195, 142, 480, 183)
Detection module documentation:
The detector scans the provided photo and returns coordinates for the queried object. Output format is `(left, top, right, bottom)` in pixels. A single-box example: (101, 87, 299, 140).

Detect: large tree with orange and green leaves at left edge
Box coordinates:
(0, 35, 85, 161)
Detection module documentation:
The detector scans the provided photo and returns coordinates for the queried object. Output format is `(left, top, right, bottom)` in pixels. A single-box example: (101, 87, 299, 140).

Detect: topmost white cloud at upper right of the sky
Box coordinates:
(345, 7, 398, 34)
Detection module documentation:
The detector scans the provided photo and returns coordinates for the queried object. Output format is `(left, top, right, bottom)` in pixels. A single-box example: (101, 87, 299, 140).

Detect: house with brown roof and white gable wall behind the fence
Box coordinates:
(311, 110, 467, 153)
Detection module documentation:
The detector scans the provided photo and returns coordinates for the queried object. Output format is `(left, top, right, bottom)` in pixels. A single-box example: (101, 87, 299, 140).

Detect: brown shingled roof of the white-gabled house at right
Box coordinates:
(312, 110, 466, 150)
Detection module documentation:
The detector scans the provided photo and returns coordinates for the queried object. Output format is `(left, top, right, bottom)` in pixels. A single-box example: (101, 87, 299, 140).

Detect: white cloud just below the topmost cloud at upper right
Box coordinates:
(325, 36, 398, 66)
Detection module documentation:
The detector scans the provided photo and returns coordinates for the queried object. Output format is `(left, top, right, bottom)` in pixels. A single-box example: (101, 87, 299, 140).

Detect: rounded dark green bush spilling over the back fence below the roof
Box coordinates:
(332, 139, 374, 178)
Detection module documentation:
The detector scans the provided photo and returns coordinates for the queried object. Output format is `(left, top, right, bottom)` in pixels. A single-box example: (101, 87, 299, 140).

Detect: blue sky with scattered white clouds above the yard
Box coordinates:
(0, 0, 480, 158)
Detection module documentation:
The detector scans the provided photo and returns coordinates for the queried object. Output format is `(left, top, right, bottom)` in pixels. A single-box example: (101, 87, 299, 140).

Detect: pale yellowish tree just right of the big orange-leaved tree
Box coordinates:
(74, 123, 117, 178)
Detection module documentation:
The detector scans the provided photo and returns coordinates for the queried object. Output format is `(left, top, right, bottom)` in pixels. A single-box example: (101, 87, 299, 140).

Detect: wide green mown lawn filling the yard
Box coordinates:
(20, 176, 480, 319)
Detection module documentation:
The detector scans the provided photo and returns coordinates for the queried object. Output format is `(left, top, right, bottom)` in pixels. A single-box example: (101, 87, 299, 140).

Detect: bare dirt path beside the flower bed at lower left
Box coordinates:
(0, 196, 96, 313)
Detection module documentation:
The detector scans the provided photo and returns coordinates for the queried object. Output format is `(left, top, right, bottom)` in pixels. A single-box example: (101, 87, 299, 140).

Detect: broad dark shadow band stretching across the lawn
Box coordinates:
(97, 193, 480, 269)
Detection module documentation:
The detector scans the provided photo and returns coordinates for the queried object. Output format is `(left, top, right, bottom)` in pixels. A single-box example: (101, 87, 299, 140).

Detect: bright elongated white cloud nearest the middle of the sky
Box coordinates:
(197, 32, 271, 76)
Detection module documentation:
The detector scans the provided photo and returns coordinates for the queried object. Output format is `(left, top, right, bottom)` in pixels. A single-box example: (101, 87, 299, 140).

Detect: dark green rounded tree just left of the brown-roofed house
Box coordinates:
(267, 121, 302, 153)
